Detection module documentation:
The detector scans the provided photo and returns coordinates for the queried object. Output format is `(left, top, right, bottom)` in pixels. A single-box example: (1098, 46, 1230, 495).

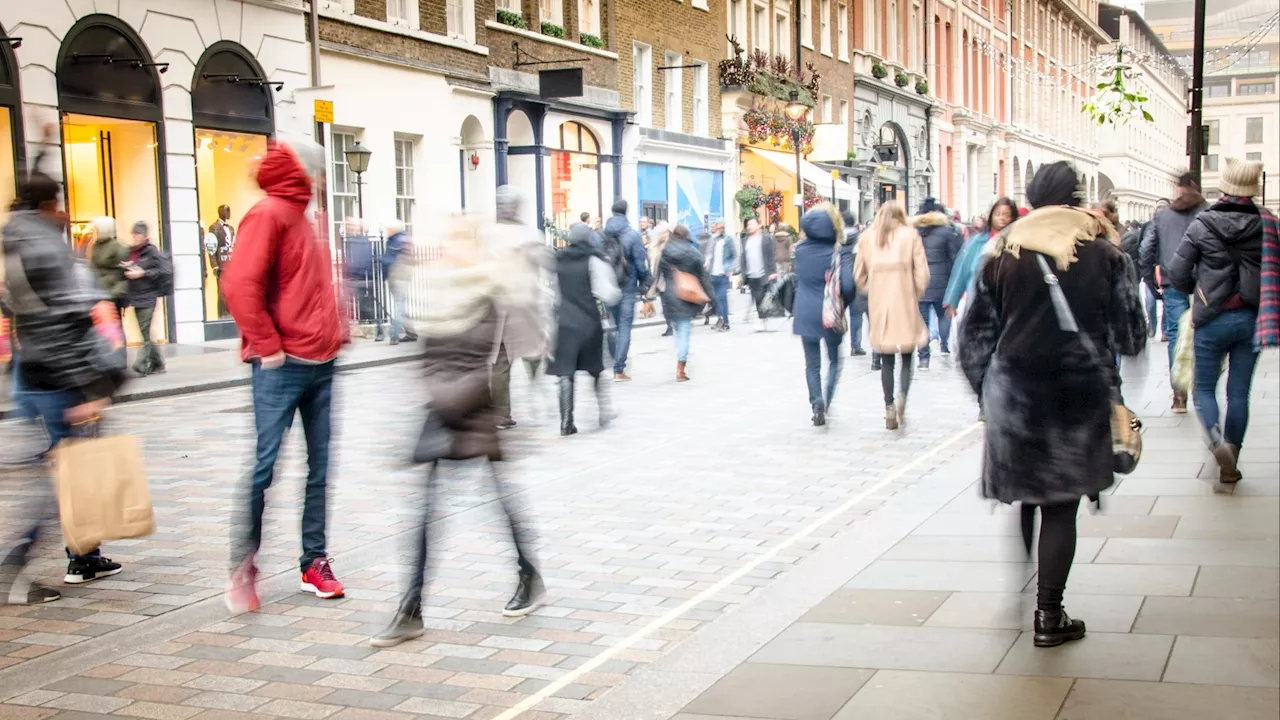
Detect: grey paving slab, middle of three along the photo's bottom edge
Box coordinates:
(833, 670, 1071, 720)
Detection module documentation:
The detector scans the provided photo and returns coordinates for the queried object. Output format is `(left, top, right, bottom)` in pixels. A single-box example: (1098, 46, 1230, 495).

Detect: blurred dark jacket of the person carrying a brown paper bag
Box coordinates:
(3, 210, 125, 400)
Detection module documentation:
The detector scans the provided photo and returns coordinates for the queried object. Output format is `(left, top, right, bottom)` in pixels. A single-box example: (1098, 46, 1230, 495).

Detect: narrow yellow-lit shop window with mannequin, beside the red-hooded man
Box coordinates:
(196, 128, 266, 320)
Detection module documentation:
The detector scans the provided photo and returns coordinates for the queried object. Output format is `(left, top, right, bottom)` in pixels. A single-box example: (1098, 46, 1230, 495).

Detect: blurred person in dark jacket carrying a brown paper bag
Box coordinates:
(0, 155, 125, 605)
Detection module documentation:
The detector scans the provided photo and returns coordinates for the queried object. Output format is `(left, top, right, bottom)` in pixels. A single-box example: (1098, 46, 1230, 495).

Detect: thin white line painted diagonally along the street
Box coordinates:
(493, 423, 982, 720)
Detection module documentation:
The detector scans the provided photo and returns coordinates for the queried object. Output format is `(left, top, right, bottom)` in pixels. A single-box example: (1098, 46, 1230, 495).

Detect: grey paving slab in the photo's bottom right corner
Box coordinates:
(1059, 680, 1280, 720)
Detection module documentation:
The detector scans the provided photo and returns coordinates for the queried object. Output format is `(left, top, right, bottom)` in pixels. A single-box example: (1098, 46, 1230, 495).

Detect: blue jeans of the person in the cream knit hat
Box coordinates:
(1187, 310, 1258, 447)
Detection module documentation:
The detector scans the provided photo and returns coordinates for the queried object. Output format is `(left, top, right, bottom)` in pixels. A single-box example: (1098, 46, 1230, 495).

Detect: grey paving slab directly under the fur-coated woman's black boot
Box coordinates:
(996, 620, 1174, 680)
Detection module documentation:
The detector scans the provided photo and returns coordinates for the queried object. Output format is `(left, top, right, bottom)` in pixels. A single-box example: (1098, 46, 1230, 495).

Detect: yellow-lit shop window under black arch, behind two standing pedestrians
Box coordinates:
(63, 113, 169, 345)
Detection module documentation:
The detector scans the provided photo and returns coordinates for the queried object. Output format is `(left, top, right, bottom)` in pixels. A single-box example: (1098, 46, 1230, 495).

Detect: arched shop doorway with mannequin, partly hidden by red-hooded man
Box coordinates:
(191, 41, 275, 340)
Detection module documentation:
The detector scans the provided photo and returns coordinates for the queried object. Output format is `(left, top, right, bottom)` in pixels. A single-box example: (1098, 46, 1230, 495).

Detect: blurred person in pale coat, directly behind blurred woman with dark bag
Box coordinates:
(484, 184, 552, 429)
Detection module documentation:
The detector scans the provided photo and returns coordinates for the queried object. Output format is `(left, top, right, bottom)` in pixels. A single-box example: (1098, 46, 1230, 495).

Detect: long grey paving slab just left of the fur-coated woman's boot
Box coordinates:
(751, 623, 1018, 673)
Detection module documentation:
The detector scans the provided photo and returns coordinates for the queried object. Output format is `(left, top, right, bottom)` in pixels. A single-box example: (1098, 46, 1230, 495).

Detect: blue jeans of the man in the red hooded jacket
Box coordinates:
(232, 360, 335, 570)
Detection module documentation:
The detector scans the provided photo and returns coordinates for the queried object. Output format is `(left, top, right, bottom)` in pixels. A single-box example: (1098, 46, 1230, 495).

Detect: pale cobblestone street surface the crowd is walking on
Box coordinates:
(0, 313, 1277, 720)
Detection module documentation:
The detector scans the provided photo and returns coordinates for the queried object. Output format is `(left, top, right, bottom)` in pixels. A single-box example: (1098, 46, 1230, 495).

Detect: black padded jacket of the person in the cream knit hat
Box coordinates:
(1167, 197, 1262, 327)
